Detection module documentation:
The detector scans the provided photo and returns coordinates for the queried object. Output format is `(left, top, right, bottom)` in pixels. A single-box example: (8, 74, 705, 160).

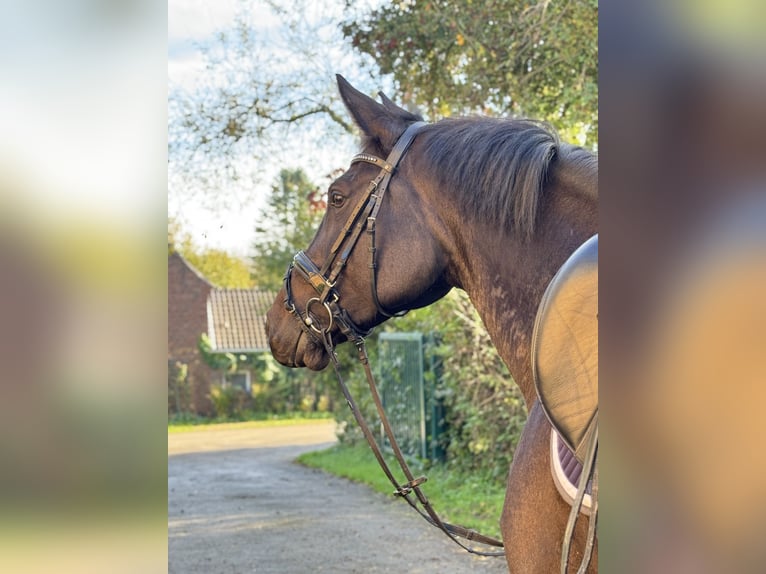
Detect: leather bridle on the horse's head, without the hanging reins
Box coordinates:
(284, 122, 426, 343)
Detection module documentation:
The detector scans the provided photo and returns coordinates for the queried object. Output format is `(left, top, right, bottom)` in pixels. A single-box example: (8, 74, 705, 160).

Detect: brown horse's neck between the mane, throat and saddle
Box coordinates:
(449, 159, 598, 408)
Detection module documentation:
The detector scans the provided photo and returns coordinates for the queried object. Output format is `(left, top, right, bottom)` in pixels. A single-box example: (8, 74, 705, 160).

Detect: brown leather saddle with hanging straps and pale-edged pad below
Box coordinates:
(532, 235, 598, 574)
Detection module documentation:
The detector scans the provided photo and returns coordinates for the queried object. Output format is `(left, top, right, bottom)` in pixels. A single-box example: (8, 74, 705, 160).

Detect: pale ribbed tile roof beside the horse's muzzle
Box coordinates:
(207, 289, 276, 353)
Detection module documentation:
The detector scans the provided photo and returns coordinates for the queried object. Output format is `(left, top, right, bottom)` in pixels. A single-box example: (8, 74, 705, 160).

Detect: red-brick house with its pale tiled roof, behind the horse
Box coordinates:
(168, 252, 275, 415)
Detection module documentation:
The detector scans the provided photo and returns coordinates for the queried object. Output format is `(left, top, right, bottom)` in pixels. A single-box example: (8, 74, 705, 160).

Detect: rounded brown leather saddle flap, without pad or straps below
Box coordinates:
(532, 235, 598, 462)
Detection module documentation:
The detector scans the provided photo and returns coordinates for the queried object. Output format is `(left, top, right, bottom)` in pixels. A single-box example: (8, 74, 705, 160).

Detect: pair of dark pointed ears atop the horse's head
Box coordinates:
(336, 74, 412, 150)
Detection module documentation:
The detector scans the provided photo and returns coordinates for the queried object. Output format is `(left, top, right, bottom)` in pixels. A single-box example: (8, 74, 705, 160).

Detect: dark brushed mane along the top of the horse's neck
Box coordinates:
(424, 117, 560, 238)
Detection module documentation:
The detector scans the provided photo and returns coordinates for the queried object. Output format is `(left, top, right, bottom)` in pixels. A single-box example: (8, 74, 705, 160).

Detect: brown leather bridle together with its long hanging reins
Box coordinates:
(284, 122, 504, 556)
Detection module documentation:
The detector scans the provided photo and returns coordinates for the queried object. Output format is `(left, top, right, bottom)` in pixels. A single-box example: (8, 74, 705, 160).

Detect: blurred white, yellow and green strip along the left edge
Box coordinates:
(0, 0, 167, 573)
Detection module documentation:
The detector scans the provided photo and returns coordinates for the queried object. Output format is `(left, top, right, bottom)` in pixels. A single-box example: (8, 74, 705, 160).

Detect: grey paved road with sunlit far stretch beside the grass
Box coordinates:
(168, 422, 507, 574)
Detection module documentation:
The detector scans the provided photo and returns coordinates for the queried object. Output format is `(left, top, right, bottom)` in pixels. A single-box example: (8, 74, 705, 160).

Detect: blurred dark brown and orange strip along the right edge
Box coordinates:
(599, 1, 766, 573)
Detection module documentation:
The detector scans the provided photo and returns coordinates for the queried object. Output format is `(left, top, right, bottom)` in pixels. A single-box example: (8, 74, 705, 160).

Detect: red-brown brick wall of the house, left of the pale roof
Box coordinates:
(168, 253, 220, 415)
